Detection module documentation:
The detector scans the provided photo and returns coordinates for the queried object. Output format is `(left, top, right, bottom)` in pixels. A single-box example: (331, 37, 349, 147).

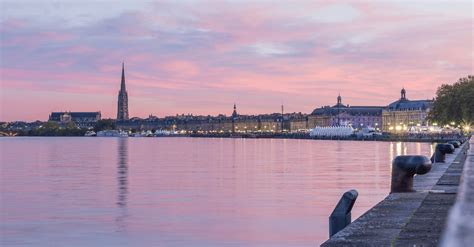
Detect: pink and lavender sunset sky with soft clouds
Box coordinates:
(0, 0, 474, 121)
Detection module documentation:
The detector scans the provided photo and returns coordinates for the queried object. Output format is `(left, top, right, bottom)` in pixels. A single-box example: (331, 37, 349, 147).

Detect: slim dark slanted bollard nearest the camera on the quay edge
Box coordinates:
(329, 190, 359, 237)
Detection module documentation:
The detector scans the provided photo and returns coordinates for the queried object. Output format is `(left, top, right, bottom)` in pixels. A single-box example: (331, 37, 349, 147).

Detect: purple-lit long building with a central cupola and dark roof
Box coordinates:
(308, 95, 384, 129)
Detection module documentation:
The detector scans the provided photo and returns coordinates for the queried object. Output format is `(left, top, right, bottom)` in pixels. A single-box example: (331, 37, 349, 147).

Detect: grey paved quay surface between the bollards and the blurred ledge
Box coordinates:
(321, 136, 474, 247)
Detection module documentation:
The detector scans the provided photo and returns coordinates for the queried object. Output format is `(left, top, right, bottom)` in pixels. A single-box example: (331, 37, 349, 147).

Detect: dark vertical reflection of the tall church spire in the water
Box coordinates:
(115, 138, 128, 231)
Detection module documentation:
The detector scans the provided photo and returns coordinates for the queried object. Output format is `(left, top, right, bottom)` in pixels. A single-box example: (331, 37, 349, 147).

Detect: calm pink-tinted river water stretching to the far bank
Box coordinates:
(0, 137, 432, 246)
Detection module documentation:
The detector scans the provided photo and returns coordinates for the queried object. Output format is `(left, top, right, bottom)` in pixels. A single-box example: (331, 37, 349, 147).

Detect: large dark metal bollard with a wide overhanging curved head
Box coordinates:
(390, 155, 431, 193)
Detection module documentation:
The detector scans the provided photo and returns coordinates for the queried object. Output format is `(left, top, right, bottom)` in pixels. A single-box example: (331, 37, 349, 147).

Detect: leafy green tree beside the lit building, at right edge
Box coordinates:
(428, 75, 474, 129)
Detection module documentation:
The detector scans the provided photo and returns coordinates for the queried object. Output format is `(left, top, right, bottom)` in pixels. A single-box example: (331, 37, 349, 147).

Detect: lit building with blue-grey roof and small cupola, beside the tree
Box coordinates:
(382, 88, 433, 132)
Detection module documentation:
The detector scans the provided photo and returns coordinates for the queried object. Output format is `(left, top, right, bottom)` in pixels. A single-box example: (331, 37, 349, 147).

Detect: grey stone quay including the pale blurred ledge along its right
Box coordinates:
(321, 138, 474, 247)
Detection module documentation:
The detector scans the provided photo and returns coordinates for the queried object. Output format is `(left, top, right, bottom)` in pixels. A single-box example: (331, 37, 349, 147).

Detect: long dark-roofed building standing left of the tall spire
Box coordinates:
(49, 111, 101, 128)
